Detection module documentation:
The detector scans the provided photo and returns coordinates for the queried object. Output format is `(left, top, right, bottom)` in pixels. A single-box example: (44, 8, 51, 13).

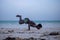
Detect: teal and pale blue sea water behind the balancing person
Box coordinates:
(0, 21, 60, 29)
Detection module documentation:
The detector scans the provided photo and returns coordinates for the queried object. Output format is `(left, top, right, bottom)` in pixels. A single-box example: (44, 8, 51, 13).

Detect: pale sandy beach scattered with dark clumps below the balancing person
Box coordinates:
(0, 27, 60, 40)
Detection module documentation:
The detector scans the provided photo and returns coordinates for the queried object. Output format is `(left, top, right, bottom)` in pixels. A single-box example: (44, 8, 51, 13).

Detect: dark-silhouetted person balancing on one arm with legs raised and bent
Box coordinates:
(16, 15, 42, 30)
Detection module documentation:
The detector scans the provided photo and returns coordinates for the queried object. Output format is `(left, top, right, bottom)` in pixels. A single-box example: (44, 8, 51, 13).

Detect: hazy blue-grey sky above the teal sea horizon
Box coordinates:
(0, 0, 60, 20)
